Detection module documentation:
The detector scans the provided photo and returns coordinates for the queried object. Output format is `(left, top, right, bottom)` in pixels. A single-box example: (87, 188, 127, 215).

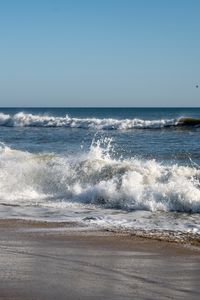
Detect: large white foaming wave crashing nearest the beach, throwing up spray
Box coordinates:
(0, 141, 200, 213)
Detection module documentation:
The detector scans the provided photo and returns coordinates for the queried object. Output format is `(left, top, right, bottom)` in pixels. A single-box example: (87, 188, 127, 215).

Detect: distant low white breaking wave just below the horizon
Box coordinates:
(0, 112, 200, 130)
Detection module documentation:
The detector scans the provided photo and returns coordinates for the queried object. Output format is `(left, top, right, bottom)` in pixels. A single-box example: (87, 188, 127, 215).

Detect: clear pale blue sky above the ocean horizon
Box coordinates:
(0, 0, 200, 106)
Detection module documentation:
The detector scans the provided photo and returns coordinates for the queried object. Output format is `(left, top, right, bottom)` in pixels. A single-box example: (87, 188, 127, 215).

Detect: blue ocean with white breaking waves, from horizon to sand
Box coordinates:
(0, 108, 200, 240)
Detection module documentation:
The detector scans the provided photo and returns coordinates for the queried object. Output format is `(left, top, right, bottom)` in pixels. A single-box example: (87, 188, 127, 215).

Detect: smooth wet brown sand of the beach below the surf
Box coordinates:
(0, 220, 200, 300)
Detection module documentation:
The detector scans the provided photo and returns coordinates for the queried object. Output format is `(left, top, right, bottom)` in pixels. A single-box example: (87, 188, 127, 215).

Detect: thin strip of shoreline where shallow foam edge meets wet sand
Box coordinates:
(0, 218, 200, 247)
